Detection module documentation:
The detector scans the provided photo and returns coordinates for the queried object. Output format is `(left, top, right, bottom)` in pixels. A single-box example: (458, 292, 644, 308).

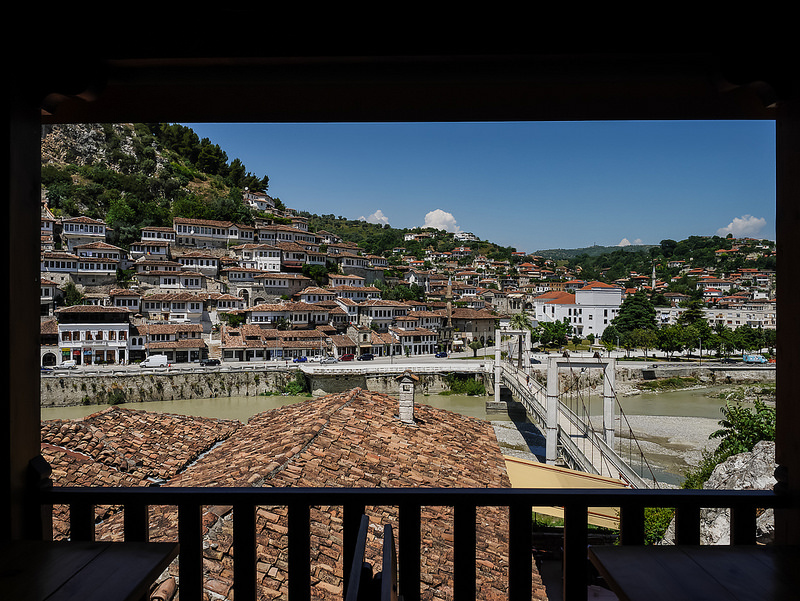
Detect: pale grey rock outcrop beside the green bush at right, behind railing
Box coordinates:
(664, 440, 776, 545)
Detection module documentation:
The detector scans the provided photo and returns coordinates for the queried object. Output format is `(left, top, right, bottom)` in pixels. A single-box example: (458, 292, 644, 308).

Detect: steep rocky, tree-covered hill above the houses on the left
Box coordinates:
(41, 123, 270, 248)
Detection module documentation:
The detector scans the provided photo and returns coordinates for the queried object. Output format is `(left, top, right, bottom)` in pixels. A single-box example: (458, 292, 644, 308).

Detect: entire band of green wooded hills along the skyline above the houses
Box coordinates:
(41, 123, 775, 281)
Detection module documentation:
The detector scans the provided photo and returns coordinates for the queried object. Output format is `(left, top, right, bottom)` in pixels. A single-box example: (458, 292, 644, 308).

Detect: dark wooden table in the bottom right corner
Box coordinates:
(589, 545, 800, 601)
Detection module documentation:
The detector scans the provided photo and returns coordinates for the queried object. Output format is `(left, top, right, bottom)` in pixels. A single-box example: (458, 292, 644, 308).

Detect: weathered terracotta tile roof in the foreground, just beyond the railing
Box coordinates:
(40, 388, 546, 600)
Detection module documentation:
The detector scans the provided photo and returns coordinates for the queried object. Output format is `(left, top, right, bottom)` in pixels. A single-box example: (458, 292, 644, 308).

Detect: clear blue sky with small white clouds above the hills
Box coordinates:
(184, 121, 775, 252)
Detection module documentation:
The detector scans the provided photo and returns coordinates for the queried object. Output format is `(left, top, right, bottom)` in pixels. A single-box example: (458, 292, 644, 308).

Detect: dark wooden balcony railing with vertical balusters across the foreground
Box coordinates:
(41, 487, 790, 601)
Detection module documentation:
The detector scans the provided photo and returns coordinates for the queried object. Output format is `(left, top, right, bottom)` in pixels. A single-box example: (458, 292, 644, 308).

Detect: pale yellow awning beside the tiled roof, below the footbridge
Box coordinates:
(503, 455, 628, 529)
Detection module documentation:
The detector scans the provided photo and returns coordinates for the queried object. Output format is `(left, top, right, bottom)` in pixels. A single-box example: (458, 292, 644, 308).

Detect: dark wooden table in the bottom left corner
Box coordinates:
(0, 541, 178, 601)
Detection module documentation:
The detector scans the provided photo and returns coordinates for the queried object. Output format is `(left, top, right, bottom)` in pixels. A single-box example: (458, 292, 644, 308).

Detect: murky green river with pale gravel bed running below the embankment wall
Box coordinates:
(41, 388, 748, 486)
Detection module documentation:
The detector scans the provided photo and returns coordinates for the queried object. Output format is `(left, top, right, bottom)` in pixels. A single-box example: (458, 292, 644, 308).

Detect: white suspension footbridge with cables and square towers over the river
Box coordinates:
(494, 352, 658, 488)
